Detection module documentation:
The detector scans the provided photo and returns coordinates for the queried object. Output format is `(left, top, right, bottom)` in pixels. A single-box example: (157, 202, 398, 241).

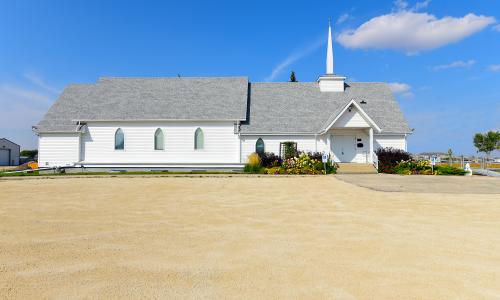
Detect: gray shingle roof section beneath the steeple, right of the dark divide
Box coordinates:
(241, 82, 410, 134)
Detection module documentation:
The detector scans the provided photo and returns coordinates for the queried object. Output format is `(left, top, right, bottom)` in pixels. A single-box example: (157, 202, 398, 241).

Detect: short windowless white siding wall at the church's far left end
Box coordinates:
(38, 133, 80, 167)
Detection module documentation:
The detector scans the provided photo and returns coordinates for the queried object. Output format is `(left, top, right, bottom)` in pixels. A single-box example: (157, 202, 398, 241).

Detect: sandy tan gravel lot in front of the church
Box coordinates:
(0, 176, 500, 299)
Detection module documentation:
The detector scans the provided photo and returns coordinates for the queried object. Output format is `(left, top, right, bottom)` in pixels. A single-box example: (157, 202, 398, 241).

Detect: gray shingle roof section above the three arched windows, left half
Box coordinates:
(36, 77, 248, 131)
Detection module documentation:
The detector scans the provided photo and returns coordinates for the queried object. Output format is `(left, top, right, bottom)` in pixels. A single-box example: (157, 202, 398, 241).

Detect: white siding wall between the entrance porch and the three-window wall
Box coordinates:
(241, 135, 316, 163)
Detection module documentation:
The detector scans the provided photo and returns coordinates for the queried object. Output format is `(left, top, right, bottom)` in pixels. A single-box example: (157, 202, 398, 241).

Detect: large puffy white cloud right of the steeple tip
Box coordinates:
(337, 11, 496, 54)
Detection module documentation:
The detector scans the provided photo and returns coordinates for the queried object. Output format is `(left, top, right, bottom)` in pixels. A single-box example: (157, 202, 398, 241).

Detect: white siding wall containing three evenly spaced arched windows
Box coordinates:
(82, 122, 239, 164)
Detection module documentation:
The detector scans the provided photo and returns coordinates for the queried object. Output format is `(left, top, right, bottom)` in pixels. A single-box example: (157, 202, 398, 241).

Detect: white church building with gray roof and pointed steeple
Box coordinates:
(33, 24, 411, 170)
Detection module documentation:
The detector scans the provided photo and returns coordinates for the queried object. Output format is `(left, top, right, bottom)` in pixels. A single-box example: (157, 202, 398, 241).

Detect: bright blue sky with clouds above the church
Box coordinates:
(0, 0, 500, 154)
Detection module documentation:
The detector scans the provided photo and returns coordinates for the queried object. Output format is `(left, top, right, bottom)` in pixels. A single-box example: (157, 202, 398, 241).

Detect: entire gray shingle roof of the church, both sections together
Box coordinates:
(35, 77, 410, 134)
